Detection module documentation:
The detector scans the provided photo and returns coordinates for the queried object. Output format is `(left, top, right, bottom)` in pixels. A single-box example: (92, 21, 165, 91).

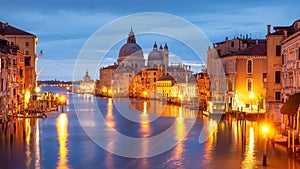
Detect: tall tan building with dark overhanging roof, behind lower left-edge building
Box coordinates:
(0, 22, 38, 94)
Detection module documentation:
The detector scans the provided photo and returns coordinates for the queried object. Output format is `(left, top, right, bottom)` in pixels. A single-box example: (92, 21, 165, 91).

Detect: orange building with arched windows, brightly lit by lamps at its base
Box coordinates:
(207, 36, 267, 113)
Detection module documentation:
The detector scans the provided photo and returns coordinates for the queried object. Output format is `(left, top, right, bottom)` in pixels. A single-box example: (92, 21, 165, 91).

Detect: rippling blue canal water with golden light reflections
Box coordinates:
(0, 88, 300, 169)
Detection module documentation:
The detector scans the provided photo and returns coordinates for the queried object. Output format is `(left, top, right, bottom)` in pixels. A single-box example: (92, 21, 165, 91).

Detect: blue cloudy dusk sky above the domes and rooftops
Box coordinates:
(0, 0, 300, 80)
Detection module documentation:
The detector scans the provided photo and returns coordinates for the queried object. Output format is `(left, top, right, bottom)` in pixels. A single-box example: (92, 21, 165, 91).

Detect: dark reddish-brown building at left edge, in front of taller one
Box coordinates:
(0, 39, 24, 119)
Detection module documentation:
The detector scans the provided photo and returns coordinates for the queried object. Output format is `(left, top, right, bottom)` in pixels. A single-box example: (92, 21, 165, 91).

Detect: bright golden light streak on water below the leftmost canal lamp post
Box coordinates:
(56, 113, 69, 169)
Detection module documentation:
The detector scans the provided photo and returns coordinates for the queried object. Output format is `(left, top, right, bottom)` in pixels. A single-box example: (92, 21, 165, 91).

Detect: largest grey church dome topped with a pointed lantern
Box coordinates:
(118, 28, 145, 69)
